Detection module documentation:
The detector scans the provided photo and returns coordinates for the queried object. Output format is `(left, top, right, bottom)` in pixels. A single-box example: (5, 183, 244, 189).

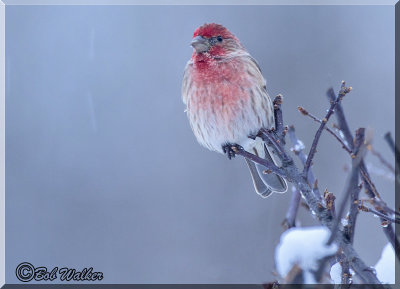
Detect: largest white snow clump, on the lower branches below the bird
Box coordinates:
(275, 227, 337, 284)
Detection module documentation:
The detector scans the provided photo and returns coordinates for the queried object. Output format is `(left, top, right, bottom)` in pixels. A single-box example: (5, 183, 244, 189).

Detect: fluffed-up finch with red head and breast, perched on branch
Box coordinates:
(182, 23, 287, 197)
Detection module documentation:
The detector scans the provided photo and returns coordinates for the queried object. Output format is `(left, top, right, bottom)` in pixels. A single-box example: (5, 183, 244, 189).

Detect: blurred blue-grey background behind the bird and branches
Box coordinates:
(6, 6, 395, 283)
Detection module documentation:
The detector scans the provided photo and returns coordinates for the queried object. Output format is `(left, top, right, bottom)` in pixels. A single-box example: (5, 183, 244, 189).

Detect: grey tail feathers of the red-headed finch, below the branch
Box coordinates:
(246, 138, 287, 198)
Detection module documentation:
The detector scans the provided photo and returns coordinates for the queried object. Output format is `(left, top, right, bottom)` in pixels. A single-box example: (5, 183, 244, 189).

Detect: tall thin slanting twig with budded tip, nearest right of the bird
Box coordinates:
(303, 81, 352, 176)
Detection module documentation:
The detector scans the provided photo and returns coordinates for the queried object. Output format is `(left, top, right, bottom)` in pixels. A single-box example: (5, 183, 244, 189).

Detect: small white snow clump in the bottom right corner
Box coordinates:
(375, 243, 395, 284)
